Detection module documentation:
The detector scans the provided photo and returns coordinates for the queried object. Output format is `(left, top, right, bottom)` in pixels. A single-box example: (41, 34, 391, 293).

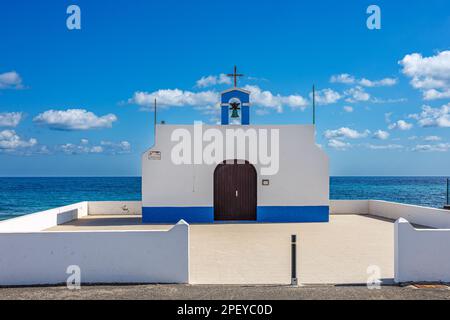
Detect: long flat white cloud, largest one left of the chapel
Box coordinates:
(33, 109, 117, 130)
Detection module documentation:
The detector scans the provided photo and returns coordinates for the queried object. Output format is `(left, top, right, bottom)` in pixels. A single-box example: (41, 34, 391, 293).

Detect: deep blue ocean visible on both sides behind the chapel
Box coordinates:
(0, 177, 446, 220)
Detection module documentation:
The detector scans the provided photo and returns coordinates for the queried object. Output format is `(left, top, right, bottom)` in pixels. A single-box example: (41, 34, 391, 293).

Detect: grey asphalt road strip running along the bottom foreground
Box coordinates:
(0, 285, 450, 300)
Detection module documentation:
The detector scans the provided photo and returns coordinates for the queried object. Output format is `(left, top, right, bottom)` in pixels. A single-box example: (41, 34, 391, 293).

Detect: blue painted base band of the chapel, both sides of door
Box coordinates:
(142, 206, 330, 223)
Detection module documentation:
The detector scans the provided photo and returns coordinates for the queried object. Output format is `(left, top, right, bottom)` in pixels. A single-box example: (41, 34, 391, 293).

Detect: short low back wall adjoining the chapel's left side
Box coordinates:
(88, 201, 142, 215)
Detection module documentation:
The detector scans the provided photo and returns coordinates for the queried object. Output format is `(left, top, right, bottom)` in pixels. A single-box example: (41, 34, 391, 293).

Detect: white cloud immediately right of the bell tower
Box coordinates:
(244, 85, 308, 112)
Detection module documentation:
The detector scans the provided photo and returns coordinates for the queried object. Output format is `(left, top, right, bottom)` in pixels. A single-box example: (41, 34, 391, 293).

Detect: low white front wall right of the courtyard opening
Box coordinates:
(394, 218, 450, 283)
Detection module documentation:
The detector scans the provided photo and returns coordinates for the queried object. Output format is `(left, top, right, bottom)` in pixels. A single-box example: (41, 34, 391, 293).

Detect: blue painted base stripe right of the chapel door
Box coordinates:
(257, 206, 330, 222)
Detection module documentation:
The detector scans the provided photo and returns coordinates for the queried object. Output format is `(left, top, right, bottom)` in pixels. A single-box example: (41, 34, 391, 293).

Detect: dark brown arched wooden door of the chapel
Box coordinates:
(214, 160, 257, 220)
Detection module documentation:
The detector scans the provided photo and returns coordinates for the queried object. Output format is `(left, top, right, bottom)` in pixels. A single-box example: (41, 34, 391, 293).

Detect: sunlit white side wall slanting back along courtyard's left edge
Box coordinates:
(0, 202, 88, 232)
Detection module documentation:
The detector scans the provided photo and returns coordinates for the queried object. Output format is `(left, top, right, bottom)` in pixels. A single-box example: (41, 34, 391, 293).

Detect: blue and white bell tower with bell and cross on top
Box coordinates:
(220, 66, 250, 125)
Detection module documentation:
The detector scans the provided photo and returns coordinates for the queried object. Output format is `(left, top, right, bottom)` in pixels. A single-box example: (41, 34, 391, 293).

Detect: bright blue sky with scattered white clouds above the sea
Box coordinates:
(0, 0, 450, 176)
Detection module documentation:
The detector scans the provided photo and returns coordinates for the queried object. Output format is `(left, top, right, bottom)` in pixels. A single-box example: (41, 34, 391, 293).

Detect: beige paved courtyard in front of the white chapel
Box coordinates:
(46, 215, 394, 284)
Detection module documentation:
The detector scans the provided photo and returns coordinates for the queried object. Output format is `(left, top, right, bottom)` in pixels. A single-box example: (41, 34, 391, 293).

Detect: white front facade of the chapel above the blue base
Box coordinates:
(142, 125, 329, 207)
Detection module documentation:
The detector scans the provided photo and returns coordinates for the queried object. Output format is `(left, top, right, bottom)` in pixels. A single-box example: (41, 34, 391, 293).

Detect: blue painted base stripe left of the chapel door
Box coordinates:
(142, 207, 214, 223)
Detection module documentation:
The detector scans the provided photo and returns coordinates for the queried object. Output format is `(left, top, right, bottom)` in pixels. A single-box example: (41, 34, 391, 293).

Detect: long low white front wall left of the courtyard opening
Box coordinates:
(0, 221, 189, 285)
